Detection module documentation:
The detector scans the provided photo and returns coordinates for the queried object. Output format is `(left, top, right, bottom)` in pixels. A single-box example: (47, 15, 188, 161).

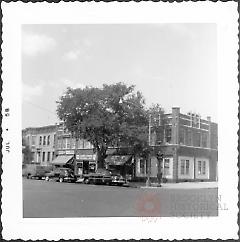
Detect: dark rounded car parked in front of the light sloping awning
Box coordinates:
(45, 168, 77, 182)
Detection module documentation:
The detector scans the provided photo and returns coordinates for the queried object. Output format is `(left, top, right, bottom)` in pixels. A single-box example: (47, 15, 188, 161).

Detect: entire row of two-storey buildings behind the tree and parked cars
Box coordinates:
(22, 108, 218, 182)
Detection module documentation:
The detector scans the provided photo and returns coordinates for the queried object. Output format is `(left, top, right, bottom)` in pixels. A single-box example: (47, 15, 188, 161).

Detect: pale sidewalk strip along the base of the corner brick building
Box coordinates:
(130, 182, 218, 189)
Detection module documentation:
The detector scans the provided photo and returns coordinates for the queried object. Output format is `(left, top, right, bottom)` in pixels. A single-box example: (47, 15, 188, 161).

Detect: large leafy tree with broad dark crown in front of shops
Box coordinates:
(57, 83, 148, 167)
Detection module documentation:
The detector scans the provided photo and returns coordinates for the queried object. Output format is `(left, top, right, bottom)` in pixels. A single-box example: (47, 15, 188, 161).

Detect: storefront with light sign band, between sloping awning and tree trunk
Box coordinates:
(75, 149, 97, 176)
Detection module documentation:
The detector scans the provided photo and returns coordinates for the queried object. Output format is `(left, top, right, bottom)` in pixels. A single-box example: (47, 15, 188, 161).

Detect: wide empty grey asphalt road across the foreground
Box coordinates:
(23, 179, 218, 218)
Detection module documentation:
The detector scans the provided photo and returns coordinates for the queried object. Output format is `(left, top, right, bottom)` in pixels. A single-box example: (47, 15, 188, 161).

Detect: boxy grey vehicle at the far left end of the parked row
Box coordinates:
(22, 164, 52, 179)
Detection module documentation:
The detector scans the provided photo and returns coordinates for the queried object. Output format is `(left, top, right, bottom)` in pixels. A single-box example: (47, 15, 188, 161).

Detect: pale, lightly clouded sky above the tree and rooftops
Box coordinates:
(22, 23, 217, 128)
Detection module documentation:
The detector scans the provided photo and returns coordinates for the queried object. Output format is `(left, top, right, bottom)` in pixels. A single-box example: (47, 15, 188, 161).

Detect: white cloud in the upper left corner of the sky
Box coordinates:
(22, 32, 56, 56)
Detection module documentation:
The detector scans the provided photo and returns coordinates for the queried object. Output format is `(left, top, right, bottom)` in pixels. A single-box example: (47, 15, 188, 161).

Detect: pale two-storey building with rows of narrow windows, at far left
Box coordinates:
(22, 125, 58, 165)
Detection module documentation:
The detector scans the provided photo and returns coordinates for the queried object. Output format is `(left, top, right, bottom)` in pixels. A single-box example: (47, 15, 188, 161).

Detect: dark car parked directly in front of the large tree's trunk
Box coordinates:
(83, 169, 112, 185)
